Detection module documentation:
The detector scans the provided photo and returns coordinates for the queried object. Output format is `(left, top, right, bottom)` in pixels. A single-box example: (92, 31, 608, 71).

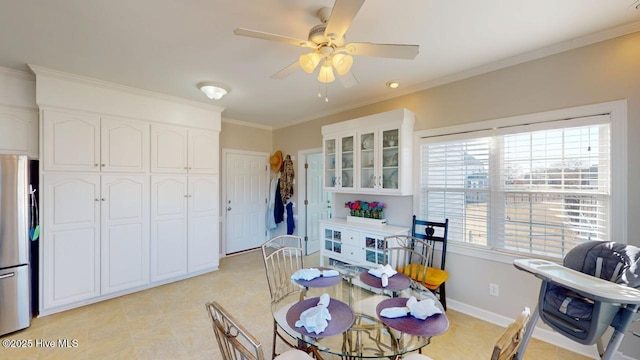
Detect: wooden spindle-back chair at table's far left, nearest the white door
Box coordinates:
(262, 235, 304, 356)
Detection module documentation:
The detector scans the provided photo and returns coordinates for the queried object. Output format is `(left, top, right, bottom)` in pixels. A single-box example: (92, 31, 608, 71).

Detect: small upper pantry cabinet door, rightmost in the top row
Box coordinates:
(188, 129, 219, 174)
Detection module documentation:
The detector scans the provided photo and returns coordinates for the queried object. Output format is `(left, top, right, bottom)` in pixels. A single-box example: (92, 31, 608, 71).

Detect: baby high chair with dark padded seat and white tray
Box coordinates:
(514, 241, 640, 360)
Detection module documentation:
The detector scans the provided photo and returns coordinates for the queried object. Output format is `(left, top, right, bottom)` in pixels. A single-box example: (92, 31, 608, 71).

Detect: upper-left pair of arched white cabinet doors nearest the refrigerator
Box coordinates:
(43, 110, 149, 172)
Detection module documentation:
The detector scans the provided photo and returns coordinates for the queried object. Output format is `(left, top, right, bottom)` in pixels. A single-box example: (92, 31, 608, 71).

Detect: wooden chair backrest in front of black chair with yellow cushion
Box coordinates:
(384, 235, 432, 281)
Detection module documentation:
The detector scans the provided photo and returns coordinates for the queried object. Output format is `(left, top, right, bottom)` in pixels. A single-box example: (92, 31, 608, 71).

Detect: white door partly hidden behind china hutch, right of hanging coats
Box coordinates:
(306, 152, 332, 255)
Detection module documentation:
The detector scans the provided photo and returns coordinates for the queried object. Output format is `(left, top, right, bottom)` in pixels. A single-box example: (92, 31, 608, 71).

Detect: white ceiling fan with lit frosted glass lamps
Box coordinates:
(233, 0, 419, 87)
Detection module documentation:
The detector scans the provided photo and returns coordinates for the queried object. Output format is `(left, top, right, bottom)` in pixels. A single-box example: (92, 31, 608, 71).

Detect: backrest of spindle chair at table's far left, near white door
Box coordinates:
(262, 235, 304, 301)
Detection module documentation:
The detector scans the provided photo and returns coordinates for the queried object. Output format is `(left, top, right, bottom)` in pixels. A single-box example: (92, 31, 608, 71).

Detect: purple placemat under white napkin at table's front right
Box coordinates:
(376, 298, 449, 337)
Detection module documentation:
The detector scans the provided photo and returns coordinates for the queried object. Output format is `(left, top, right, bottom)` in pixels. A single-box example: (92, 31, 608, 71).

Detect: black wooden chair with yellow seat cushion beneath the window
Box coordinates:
(411, 215, 449, 310)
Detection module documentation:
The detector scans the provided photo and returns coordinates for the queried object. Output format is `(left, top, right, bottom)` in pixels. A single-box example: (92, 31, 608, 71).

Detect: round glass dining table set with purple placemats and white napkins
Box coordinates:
(272, 266, 449, 359)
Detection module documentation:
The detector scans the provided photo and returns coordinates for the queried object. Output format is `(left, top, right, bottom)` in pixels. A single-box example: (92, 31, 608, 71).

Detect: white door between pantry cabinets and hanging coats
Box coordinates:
(223, 152, 268, 254)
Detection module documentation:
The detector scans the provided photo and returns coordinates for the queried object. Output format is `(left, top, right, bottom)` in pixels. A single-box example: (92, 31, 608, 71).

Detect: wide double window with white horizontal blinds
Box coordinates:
(417, 102, 626, 258)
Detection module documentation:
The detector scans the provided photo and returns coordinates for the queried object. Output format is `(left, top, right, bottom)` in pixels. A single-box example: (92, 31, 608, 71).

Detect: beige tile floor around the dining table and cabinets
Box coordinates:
(0, 251, 587, 360)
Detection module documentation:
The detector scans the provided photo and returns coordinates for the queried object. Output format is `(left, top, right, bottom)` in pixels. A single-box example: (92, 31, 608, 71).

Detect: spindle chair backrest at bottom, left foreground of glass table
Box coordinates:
(205, 301, 264, 360)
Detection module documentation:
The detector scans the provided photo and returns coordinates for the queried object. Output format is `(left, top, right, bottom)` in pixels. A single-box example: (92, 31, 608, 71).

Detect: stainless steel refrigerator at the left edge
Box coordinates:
(0, 155, 31, 335)
